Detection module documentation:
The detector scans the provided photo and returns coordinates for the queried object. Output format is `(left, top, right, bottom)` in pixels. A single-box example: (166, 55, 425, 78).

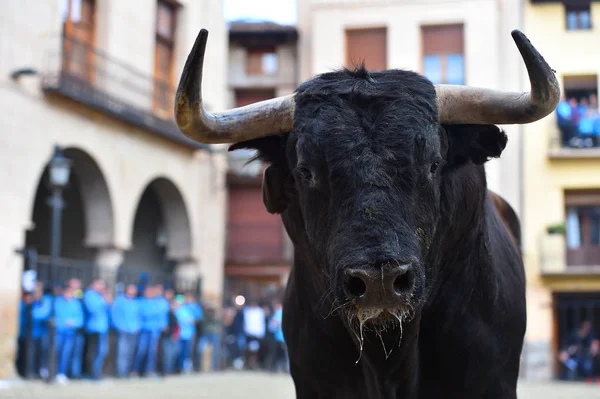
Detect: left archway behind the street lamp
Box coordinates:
(25, 148, 114, 284)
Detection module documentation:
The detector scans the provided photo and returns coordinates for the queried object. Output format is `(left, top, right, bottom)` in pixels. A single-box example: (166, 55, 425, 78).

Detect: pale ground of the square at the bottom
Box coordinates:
(0, 372, 600, 399)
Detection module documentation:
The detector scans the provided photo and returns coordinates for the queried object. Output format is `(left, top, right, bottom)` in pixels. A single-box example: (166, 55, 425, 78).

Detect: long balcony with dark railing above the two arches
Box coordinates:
(42, 36, 208, 149)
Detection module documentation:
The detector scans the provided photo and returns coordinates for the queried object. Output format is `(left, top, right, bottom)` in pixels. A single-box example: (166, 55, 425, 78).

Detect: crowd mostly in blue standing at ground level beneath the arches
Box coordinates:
(17, 279, 288, 383)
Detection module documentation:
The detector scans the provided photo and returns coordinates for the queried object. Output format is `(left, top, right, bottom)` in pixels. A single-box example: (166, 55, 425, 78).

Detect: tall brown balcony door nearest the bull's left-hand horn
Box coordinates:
(153, 0, 176, 118)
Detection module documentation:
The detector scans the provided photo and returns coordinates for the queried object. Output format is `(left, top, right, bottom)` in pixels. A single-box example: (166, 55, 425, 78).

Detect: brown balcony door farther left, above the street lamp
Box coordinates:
(61, 0, 95, 82)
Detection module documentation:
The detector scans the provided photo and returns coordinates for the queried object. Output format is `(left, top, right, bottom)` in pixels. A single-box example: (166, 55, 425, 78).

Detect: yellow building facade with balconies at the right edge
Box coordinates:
(521, 0, 600, 378)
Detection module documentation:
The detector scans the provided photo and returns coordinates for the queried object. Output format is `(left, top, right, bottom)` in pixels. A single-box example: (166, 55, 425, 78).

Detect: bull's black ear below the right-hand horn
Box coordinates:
(444, 125, 508, 167)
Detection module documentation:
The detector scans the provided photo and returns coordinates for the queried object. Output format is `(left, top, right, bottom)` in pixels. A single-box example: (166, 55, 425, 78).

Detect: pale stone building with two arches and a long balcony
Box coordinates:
(0, 0, 229, 379)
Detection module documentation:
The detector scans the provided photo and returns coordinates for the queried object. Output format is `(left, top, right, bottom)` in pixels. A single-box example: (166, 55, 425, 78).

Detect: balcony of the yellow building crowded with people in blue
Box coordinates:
(550, 96, 600, 158)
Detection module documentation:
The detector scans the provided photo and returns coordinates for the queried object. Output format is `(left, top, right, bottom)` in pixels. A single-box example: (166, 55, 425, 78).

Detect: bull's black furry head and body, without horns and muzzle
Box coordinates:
(232, 67, 526, 399)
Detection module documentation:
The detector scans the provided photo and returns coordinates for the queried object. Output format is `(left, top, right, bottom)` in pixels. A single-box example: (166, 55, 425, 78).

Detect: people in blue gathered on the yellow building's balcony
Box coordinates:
(556, 94, 600, 148)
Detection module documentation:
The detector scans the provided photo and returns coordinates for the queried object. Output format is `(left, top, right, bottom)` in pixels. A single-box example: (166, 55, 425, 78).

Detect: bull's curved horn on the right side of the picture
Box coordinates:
(435, 30, 560, 125)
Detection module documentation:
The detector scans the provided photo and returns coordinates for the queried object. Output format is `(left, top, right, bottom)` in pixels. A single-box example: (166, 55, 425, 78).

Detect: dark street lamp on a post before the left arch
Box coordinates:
(47, 146, 72, 382)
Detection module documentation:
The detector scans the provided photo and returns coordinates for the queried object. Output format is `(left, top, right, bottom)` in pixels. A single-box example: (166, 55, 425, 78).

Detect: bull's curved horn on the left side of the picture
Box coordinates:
(175, 29, 295, 144)
